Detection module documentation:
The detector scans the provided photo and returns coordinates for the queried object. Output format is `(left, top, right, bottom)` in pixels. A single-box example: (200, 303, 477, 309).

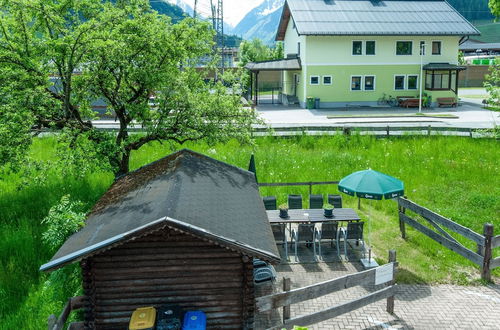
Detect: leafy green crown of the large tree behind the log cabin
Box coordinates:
(0, 0, 256, 176)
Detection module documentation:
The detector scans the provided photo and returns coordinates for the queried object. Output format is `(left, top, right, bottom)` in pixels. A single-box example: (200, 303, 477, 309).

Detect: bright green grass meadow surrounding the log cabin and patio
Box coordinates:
(0, 135, 500, 329)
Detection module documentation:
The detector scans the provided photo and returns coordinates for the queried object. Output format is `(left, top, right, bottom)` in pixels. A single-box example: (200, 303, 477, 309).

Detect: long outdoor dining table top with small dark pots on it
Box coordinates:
(267, 208, 361, 224)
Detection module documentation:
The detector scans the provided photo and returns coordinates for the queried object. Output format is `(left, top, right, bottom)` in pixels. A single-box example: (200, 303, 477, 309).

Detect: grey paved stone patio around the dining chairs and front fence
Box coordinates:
(256, 244, 500, 329)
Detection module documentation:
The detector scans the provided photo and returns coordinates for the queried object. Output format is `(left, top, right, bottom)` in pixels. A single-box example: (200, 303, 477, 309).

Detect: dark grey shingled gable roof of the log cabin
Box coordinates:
(41, 149, 279, 270)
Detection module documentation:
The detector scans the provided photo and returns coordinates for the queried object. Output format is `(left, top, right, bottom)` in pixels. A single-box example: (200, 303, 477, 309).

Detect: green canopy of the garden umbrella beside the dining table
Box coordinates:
(339, 169, 404, 200)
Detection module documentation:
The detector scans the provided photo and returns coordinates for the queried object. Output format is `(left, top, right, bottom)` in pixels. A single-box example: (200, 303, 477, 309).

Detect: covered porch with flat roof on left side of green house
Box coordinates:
(245, 56, 302, 106)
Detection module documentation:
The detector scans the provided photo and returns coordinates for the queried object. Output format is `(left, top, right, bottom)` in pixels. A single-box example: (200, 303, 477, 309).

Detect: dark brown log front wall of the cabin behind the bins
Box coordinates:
(84, 228, 254, 329)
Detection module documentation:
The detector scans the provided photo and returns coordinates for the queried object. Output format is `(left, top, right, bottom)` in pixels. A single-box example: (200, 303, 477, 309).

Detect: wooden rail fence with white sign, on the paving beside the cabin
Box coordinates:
(256, 250, 397, 329)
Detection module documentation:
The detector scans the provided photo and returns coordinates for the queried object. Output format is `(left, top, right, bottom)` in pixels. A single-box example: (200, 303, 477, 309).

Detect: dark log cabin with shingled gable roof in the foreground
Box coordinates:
(40, 149, 280, 329)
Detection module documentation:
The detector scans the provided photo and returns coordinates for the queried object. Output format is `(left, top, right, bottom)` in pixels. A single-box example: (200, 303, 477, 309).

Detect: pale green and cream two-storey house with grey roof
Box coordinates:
(248, 0, 479, 108)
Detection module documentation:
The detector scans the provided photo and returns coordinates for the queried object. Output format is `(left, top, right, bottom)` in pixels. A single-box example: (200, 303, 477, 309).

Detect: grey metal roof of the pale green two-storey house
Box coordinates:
(276, 0, 480, 40)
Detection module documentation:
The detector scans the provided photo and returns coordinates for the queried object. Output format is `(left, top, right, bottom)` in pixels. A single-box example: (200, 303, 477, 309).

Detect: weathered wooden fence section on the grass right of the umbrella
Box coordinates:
(398, 197, 500, 281)
